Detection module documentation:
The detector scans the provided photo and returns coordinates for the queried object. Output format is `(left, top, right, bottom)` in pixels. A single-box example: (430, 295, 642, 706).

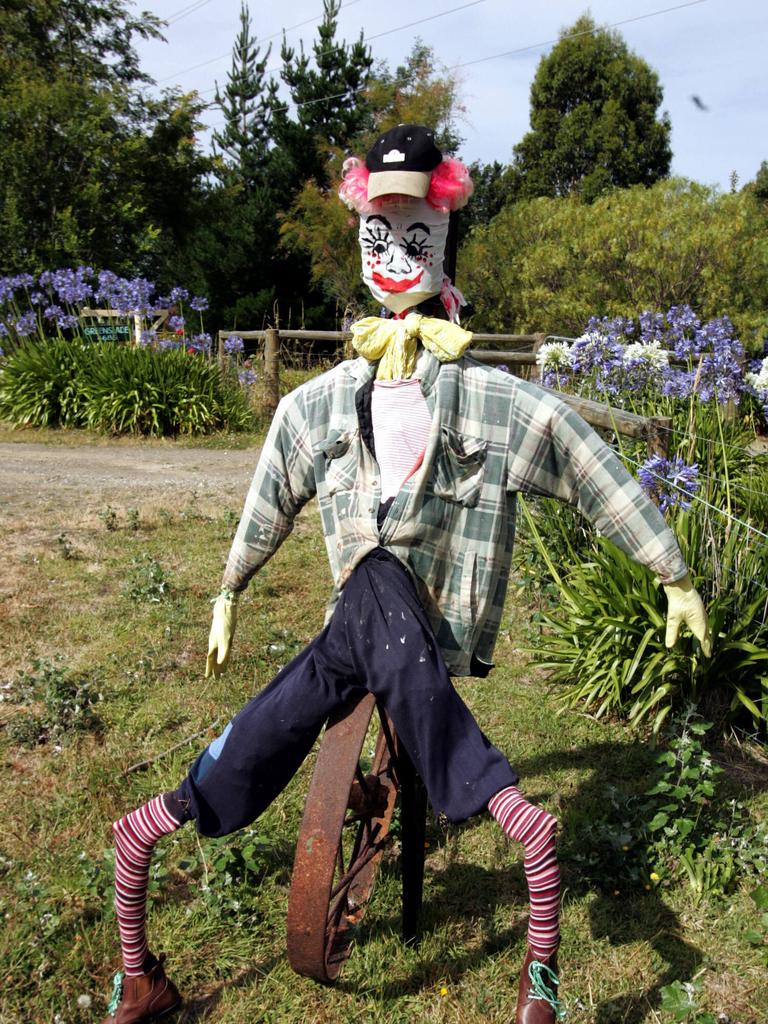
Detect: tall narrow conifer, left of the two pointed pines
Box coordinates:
(213, 2, 278, 194)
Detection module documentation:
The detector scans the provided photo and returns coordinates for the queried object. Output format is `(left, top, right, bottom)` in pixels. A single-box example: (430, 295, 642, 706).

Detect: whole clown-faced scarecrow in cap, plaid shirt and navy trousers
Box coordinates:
(104, 125, 709, 1024)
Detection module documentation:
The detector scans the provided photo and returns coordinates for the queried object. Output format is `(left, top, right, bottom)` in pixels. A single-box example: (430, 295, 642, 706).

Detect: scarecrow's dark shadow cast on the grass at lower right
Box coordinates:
(340, 742, 703, 1024)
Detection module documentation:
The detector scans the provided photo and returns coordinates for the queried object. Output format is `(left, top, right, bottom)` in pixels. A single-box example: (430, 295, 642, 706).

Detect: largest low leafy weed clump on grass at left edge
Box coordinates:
(2, 658, 103, 746)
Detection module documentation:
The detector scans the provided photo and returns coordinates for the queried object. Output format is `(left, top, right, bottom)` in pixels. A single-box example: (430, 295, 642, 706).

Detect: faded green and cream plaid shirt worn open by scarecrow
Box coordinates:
(223, 353, 687, 675)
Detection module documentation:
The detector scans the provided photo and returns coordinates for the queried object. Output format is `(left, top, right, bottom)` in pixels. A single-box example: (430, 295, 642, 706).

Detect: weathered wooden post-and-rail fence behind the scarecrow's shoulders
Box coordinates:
(218, 328, 672, 456)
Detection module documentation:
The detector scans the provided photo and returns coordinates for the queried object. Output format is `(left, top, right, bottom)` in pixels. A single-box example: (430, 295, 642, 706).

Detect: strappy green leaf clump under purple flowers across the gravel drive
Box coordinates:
(0, 340, 259, 436)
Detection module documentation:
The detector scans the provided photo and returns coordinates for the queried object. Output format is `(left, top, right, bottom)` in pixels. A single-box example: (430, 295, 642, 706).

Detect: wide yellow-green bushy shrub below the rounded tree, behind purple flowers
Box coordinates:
(458, 179, 768, 348)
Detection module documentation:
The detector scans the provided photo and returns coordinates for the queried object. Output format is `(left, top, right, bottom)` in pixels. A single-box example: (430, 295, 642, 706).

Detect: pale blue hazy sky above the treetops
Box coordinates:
(136, 0, 768, 191)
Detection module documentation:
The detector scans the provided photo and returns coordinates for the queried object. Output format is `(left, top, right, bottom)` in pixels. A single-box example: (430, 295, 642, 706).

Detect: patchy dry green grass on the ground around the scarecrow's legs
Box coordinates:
(0, 491, 768, 1024)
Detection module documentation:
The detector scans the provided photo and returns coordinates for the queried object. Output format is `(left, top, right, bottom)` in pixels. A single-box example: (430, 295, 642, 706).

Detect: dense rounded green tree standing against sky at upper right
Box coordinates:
(514, 14, 672, 202)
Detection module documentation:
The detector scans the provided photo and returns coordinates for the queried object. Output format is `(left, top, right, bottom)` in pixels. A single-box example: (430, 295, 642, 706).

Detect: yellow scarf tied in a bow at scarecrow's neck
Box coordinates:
(352, 313, 472, 381)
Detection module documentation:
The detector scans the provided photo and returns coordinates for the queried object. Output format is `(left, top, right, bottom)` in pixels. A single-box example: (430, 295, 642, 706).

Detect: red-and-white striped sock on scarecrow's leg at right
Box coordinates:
(488, 785, 560, 957)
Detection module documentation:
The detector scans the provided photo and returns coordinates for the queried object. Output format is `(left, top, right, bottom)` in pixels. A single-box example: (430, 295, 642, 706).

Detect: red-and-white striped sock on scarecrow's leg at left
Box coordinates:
(112, 797, 179, 977)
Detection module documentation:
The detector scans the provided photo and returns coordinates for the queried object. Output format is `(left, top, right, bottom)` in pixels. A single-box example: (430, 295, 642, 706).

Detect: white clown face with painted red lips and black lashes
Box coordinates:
(359, 199, 450, 313)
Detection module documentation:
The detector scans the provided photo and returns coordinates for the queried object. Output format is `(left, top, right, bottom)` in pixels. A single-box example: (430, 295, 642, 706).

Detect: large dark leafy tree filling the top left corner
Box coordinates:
(0, 0, 210, 273)
